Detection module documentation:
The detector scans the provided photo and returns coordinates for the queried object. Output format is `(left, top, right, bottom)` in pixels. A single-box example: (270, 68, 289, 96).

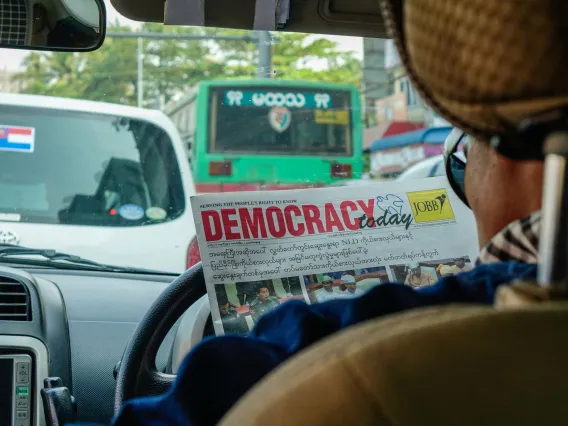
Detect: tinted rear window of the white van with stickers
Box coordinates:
(0, 105, 185, 226)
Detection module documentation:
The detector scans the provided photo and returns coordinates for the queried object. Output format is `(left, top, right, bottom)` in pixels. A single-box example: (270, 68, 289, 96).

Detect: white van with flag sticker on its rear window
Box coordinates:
(0, 93, 195, 273)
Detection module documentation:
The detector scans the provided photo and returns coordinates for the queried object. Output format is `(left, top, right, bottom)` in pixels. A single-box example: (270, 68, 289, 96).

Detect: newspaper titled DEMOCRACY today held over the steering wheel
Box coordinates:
(191, 177, 478, 335)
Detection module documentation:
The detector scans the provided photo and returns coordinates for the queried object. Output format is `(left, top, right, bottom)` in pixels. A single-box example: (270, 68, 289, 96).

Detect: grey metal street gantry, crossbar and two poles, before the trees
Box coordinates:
(106, 31, 278, 107)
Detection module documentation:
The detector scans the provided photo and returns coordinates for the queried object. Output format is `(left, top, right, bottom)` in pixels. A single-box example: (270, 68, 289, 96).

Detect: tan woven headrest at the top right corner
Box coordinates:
(380, 0, 568, 138)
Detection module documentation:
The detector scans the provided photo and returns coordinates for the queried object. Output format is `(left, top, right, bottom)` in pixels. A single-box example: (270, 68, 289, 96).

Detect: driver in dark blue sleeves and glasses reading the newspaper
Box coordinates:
(97, 126, 543, 426)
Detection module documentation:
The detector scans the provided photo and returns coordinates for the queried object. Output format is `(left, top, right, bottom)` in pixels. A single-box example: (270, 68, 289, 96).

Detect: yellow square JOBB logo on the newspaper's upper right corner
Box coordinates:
(406, 189, 455, 223)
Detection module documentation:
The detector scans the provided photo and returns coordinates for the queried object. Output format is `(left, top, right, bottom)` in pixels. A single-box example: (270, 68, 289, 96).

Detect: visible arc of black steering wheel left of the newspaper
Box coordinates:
(114, 262, 207, 414)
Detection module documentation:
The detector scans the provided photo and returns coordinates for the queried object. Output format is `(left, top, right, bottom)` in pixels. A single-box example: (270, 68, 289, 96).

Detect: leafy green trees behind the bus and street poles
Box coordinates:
(16, 22, 361, 107)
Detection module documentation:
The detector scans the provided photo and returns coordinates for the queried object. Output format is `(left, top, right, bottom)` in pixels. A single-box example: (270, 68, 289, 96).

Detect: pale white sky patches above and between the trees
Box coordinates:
(0, 0, 363, 71)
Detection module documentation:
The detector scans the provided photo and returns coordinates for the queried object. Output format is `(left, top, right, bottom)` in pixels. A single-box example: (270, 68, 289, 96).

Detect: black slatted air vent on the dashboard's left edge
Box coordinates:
(0, 276, 32, 321)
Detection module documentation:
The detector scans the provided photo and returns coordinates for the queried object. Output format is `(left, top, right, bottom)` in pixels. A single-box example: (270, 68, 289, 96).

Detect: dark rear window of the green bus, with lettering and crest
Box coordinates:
(208, 86, 353, 157)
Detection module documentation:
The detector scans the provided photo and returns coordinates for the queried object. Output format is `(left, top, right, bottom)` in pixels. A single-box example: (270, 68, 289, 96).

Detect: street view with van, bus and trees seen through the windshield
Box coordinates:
(0, 2, 451, 273)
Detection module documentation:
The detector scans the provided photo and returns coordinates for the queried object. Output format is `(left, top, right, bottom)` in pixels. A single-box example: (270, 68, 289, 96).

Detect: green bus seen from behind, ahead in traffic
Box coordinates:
(164, 79, 363, 193)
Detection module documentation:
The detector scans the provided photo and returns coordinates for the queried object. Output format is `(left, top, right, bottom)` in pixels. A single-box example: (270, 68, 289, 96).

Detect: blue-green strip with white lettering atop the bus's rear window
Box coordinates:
(224, 90, 332, 109)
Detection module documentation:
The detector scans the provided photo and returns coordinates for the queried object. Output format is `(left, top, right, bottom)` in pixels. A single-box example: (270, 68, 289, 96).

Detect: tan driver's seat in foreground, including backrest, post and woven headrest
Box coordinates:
(221, 0, 568, 426)
